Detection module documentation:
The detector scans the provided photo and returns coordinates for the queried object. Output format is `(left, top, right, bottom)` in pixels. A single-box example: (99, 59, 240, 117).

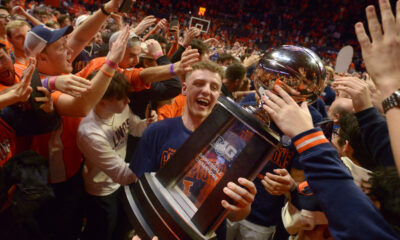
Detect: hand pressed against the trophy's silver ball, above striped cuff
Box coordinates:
(262, 85, 314, 138)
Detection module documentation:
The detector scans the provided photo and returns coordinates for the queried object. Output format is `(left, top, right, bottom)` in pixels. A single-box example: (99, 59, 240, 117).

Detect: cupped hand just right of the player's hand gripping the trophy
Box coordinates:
(261, 168, 296, 195)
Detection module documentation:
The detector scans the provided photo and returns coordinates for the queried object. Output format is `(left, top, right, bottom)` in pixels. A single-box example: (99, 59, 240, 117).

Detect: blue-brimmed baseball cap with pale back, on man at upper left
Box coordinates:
(24, 25, 74, 57)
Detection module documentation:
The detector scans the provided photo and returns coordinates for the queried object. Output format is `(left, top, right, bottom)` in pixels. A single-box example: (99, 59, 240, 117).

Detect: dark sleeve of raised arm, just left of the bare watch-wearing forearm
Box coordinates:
(356, 107, 395, 166)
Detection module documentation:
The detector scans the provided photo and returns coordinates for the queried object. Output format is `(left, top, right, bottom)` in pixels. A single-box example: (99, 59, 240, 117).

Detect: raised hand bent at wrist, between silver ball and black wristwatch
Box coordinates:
(332, 77, 373, 112)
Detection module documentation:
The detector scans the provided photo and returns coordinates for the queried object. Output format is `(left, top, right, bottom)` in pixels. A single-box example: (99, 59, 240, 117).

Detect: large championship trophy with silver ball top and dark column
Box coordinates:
(123, 46, 325, 240)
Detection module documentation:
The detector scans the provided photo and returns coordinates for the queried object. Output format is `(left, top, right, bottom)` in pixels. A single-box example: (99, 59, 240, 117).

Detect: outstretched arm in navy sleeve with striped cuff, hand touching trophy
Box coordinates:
(263, 86, 397, 239)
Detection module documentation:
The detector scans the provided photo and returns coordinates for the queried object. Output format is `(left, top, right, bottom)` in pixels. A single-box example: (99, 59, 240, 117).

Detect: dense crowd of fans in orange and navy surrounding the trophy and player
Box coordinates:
(0, 0, 400, 240)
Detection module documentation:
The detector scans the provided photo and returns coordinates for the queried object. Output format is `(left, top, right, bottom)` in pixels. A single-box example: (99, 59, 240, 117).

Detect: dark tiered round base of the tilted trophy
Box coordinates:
(122, 173, 215, 240)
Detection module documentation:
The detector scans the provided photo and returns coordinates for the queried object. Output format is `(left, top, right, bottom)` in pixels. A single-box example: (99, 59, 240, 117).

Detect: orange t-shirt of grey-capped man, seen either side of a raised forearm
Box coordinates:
(76, 57, 150, 92)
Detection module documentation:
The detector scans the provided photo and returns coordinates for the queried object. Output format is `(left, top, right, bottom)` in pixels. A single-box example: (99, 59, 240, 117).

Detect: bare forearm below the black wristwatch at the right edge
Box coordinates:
(386, 108, 400, 174)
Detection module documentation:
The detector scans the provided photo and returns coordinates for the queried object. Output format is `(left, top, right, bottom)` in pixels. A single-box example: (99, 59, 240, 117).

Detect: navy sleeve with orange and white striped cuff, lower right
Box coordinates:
(292, 128, 397, 239)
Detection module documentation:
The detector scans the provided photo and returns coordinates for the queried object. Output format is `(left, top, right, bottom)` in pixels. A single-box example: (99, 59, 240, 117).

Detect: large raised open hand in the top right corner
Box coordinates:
(355, 0, 400, 98)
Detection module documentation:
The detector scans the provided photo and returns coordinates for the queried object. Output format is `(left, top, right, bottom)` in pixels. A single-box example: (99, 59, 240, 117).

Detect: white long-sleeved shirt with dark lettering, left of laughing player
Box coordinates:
(77, 106, 147, 196)
